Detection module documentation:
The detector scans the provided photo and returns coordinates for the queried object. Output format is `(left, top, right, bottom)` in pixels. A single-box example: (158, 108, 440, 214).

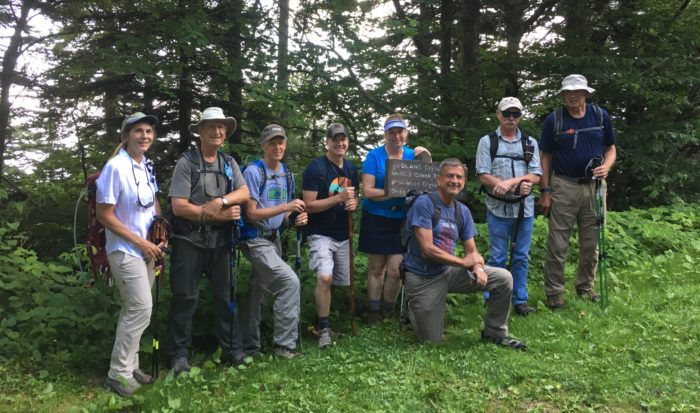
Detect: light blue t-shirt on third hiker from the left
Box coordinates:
(243, 162, 294, 230)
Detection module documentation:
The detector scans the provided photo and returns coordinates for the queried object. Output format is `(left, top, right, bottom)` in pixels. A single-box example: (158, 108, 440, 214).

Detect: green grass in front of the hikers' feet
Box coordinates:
(0, 217, 700, 413)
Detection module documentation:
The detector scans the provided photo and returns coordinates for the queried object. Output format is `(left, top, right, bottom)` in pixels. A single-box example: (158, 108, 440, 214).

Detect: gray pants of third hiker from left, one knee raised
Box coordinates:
(241, 237, 301, 354)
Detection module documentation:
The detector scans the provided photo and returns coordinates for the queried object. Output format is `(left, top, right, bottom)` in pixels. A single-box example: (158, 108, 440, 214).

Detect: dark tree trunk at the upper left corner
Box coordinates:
(0, 0, 34, 177)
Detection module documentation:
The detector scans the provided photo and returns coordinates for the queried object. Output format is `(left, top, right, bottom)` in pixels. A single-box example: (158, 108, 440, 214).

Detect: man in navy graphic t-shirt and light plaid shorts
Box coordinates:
(302, 123, 359, 348)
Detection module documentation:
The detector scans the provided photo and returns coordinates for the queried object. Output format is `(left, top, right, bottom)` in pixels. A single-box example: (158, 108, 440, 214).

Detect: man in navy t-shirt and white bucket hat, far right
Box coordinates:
(539, 75, 617, 310)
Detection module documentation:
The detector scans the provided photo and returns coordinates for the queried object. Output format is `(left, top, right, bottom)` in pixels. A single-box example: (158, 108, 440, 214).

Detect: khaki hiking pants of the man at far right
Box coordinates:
(544, 175, 606, 295)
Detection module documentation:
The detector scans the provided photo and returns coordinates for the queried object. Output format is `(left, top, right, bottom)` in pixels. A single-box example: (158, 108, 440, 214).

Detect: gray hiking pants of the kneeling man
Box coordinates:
(405, 266, 513, 342)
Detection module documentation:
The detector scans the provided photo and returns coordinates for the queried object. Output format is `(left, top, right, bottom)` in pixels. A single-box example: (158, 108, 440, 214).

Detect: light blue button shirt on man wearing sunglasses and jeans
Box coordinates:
(476, 127, 542, 218)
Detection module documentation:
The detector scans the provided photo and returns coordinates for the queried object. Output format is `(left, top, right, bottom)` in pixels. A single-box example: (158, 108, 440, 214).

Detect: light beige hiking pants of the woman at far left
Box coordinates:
(107, 251, 155, 379)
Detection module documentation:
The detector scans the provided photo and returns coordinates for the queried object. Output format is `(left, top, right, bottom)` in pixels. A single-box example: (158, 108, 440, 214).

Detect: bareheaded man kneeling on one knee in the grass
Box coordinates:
(403, 158, 526, 350)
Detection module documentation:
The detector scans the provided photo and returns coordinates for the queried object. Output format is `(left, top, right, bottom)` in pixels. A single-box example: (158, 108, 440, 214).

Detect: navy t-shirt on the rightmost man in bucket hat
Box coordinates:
(540, 103, 617, 178)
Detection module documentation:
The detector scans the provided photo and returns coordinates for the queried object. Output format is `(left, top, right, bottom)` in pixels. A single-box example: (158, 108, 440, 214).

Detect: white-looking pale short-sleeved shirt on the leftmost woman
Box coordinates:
(95, 149, 158, 258)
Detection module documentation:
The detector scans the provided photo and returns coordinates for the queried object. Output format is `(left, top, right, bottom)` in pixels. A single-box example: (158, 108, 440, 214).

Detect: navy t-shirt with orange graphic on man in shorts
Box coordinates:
(302, 155, 360, 241)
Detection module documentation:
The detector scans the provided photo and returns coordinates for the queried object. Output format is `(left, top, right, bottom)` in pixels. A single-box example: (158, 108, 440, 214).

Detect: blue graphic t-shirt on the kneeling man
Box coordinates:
(403, 195, 476, 276)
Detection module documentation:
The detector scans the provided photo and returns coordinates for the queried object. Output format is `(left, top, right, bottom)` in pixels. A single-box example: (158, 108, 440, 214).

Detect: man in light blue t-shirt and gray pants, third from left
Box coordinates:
(241, 124, 308, 358)
